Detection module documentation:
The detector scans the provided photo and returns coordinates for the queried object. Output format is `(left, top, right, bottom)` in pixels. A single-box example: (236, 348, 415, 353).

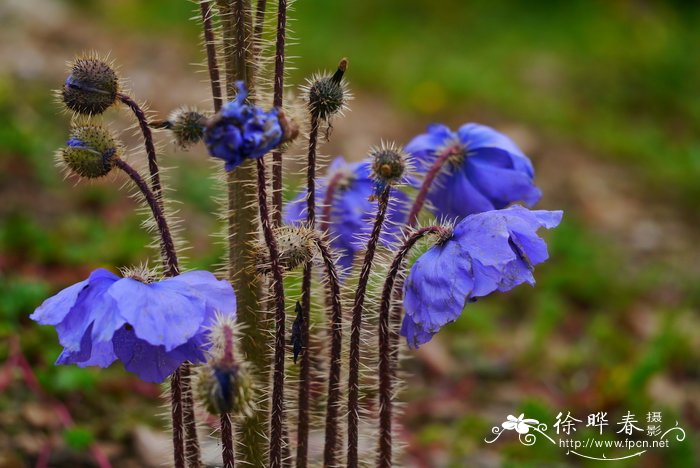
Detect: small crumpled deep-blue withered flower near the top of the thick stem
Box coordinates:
(204, 81, 284, 171)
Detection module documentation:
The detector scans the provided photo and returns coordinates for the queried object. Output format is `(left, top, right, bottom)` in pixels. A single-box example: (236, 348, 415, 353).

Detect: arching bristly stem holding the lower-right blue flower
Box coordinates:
(377, 226, 449, 468)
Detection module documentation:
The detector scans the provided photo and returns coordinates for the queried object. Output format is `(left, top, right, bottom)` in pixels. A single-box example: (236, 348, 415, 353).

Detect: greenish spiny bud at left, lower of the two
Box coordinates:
(59, 124, 120, 179)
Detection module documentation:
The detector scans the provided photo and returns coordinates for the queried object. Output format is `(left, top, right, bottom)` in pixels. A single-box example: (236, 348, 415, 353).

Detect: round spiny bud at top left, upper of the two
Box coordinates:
(61, 56, 119, 115)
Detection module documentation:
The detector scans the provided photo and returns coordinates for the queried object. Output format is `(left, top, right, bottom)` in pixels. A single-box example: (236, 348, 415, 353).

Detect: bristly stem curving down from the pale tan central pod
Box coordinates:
(308, 233, 343, 466)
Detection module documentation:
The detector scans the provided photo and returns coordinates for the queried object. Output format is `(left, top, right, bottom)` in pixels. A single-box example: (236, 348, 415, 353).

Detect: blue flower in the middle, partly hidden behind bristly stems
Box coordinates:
(284, 156, 408, 268)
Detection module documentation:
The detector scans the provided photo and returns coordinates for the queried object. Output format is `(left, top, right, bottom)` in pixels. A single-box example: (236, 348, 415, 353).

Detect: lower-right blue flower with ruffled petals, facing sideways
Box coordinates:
(401, 205, 562, 348)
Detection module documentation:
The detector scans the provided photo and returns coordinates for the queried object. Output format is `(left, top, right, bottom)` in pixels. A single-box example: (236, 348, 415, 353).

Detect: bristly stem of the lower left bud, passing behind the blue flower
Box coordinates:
(114, 159, 186, 468)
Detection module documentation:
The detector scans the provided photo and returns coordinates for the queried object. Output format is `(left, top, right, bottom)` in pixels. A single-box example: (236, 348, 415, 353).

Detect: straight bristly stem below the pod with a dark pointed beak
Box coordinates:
(297, 111, 319, 467)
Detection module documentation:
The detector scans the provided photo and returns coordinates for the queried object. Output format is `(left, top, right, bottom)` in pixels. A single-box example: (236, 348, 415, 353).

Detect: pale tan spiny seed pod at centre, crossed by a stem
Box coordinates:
(253, 226, 316, 275)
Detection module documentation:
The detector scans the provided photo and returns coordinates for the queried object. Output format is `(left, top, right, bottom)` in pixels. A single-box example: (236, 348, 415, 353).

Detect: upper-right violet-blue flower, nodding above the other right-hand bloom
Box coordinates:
(405, 123, 542, 219)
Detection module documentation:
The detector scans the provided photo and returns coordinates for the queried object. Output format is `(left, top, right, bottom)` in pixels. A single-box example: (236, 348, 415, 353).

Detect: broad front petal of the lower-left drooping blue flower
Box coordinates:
(109, 278, 205, 351)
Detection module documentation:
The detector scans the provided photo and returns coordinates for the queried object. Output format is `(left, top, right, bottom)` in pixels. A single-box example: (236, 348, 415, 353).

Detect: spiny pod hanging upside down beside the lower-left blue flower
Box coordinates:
(193, 316, 253, 416)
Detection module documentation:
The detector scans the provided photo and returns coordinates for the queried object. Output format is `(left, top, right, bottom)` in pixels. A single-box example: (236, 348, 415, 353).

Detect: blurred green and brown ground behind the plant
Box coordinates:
(0, 0, 700, 467)
